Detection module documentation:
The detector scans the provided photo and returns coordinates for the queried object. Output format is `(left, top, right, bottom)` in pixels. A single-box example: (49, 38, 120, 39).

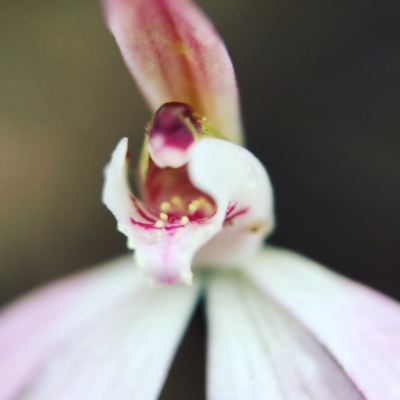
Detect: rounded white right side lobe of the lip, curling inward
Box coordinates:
(189, 138, 274, 266)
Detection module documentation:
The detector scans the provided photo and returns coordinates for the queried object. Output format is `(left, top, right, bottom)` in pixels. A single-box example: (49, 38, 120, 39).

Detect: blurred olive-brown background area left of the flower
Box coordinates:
(0, 1, 150, 302)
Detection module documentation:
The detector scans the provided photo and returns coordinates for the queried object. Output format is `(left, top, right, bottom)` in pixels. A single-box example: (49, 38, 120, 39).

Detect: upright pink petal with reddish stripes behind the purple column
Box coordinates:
(103, 0, 242, 143)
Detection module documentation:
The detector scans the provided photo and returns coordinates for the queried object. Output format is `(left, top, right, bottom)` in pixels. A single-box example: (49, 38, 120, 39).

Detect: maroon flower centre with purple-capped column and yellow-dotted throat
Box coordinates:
(141, 102, 216, 228)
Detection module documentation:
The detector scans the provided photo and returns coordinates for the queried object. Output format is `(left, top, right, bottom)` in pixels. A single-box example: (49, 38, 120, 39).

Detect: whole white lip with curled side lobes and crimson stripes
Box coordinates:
(103, 138, 273, 284)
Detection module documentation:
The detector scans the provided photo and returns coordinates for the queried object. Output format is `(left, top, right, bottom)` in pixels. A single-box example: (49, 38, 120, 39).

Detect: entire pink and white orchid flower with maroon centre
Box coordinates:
(0, 0, 400, 400)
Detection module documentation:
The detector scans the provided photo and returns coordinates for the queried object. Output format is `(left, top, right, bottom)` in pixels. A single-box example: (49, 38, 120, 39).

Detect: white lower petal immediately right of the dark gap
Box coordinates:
(207, 272, 363, 400)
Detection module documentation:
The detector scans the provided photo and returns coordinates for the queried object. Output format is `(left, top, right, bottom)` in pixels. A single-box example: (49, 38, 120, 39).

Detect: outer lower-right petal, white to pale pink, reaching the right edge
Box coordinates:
(245, 248, 400, 400)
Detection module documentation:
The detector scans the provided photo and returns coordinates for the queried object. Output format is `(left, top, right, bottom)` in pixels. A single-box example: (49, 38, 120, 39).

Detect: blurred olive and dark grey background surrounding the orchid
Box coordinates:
(0, 0, 400, 399)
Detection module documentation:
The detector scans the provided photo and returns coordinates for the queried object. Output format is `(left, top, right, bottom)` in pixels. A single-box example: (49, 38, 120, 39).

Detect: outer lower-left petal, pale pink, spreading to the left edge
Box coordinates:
(0, 257, 143, 400)
